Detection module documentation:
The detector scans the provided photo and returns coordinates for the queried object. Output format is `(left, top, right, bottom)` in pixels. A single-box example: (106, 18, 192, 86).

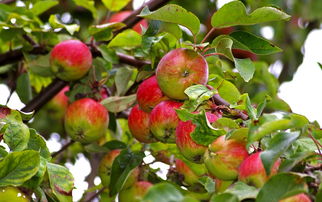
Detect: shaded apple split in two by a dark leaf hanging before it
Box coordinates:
(98, 149, 139, 189)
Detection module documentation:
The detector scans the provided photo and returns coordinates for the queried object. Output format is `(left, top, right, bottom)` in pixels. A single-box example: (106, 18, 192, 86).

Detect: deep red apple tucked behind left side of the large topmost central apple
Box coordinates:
(136, 76, 169, 112)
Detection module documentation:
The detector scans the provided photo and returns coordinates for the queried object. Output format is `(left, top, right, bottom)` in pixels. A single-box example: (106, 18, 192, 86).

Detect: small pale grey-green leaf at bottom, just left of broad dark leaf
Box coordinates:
(225, 181, 258, 201)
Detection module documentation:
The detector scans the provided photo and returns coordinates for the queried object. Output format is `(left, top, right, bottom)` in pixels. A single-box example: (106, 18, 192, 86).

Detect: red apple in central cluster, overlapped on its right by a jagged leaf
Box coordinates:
(176, 112, 218, 163)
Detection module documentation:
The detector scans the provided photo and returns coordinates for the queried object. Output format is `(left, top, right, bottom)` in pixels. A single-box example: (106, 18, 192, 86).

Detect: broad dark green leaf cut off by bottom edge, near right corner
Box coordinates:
(256, 173, 307, 202)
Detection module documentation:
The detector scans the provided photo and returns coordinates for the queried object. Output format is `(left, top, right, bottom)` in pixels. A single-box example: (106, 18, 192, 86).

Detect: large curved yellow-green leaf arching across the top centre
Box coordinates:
(139, 4, 200, 35)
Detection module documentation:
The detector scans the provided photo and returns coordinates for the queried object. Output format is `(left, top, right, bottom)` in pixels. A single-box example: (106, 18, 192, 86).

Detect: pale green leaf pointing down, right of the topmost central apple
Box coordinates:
(234, 58, 255, 82)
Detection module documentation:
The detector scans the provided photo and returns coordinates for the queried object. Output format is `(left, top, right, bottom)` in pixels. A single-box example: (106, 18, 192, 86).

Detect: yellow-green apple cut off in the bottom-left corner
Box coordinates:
(0, 187, 30, 202)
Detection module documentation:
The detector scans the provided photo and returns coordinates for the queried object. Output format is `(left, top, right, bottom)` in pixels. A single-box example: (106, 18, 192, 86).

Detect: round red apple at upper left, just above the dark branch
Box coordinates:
(50, 40, 92, 81)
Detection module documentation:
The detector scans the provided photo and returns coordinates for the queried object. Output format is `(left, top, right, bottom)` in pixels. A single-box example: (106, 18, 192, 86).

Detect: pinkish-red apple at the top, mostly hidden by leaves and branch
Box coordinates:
(101, 11, 148, 34)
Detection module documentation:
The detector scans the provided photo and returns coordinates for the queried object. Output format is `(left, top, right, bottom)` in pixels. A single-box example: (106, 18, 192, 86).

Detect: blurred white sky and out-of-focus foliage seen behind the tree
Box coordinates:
(0, 0, 322, 200)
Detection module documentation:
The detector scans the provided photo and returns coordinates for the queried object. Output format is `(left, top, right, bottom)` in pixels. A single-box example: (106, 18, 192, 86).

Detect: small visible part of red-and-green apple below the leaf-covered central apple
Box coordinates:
(176, 159, 199, 185)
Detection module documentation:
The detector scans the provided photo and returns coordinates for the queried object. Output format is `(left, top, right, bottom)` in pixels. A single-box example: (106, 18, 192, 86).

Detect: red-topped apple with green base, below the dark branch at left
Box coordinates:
(64, 98, 109, 144)
